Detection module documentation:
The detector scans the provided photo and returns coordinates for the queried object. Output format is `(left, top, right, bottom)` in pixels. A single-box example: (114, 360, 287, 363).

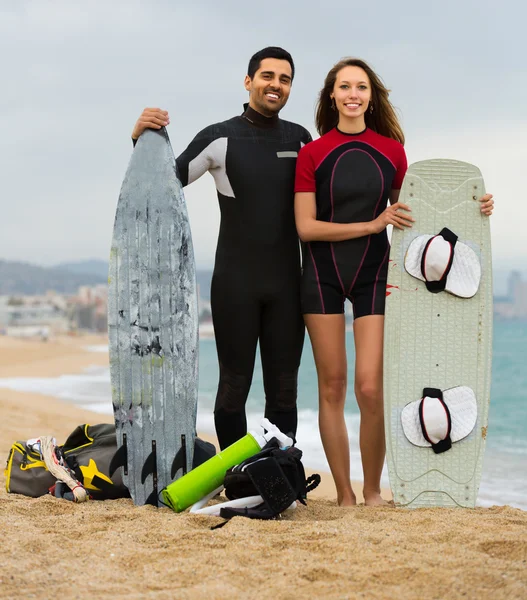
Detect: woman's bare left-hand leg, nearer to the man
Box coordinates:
(304, 315, 357, 506)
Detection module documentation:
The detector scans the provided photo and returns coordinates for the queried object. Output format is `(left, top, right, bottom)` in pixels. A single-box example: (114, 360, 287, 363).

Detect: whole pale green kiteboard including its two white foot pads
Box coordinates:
(384, 159, 492, 507)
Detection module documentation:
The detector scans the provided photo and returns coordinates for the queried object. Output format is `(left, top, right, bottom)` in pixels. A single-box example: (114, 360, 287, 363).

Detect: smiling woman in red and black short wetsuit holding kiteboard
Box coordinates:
(295, 58, 493, 506)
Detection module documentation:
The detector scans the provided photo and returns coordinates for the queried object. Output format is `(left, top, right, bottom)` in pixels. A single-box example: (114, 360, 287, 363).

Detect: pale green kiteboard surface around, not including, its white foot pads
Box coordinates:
(384, 159, 492, 508)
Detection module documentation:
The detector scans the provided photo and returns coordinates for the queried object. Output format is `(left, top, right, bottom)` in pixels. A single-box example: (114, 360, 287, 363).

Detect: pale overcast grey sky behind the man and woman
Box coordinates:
(0, 0, 527, 268)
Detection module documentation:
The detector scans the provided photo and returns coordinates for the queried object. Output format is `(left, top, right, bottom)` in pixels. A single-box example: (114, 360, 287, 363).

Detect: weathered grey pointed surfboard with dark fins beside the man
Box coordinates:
(108, 128, 198, 506)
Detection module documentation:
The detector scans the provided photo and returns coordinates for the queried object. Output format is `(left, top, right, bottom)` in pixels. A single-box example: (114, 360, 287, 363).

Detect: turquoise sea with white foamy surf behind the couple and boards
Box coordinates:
(0, 321, 527, 510)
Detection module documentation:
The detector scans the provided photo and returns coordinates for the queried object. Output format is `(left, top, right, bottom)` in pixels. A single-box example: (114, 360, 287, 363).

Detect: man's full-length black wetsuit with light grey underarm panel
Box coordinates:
(176, 105, 311, 448)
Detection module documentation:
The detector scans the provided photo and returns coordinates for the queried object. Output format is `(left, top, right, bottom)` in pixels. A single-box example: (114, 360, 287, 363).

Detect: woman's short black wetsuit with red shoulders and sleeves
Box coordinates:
(295, 128, 407, 318)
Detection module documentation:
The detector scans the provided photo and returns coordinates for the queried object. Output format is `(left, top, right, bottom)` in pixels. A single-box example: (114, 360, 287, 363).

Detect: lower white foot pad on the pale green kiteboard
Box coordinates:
(401, 386, 478, 448)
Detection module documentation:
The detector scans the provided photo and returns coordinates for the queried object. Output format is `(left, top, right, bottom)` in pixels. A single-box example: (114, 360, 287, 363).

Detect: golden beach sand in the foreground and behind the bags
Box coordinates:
(0, 336, 527, 600)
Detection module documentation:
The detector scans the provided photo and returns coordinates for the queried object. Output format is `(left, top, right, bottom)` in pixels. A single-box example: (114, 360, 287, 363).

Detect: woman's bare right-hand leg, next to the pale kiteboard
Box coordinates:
(353, 315, 388, 506)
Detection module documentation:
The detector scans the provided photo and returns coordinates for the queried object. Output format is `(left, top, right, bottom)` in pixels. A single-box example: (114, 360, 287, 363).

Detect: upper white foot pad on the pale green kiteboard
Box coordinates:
(404, 235, 481, 298)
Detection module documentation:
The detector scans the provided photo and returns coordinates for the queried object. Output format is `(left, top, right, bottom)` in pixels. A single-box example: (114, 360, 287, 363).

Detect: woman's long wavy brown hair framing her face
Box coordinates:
(315, 58, 404, 144)
